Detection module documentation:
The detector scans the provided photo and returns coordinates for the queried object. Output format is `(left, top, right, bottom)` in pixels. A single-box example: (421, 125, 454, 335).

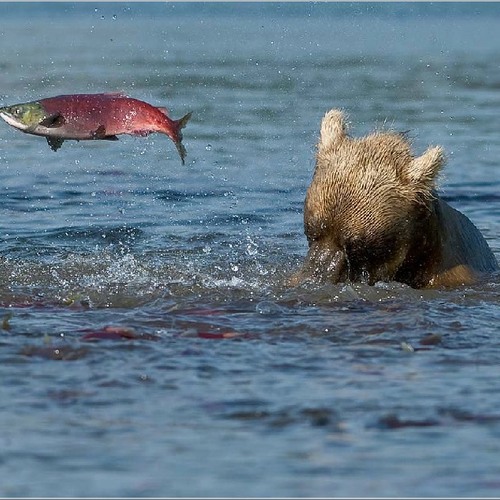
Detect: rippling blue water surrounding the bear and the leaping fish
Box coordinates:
(0, 3, 500, 496)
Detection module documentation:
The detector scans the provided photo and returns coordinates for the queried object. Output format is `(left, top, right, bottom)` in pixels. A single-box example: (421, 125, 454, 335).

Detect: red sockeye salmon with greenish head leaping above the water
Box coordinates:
(0, 93, 191, 164)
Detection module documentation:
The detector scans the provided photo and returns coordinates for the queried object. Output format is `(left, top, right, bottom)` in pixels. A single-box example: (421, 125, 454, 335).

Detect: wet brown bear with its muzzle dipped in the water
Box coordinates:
(294, 109, 498, 288)
